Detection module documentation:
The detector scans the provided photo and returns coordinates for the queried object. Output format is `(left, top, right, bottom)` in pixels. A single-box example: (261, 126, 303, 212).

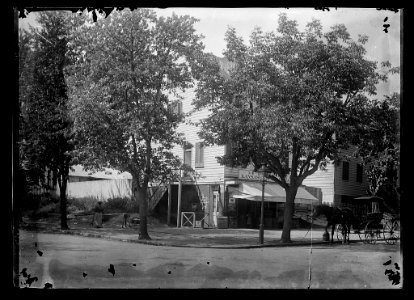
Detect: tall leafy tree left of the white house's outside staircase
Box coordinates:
(67, 9, 203, 239)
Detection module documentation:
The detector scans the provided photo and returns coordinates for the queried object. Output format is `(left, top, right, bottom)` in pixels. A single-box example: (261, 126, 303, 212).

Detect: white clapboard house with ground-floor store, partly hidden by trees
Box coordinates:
(155, 61, 367, 228)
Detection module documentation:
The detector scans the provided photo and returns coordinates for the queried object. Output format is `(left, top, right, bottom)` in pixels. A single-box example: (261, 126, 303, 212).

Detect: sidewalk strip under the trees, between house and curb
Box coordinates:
(21, 219, 359, 249)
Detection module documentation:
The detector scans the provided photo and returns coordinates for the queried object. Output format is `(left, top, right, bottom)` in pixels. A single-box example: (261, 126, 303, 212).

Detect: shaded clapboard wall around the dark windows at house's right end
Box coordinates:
(334, 148, 368, 196)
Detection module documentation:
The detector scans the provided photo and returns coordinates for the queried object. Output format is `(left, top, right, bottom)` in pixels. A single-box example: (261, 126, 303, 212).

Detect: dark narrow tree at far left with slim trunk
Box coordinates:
(20, 12, 73, 229)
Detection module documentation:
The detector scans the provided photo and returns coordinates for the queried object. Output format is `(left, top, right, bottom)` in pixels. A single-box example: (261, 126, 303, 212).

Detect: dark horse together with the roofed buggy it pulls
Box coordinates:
(313, 196, 400, 245)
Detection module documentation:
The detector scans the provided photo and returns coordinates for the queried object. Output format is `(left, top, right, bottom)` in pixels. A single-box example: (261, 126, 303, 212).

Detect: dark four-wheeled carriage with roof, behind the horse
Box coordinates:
(336, 196, 400, 245)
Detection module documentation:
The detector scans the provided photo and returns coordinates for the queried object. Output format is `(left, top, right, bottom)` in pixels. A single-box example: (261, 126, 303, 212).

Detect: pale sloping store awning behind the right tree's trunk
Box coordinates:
(229, 182, 319, 204)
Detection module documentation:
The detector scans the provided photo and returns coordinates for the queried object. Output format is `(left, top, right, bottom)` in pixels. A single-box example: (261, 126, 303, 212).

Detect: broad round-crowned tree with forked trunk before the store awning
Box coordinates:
(194, 14, 396, 243)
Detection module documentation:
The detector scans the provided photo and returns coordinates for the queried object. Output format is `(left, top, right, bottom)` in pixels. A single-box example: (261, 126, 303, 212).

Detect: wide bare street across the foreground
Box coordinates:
(19, 230, 403, 289)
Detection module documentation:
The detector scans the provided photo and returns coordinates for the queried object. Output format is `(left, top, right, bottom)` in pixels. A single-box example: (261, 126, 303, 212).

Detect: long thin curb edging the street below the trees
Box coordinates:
(21, 227, 362, 249)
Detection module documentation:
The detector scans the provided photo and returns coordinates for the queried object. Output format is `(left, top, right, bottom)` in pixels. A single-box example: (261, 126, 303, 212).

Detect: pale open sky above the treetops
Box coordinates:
(19, 7, 401, 97)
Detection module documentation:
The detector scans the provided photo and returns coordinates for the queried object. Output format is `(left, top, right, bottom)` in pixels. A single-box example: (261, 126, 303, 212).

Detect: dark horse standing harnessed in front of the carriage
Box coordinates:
(312, 204, 356, 244)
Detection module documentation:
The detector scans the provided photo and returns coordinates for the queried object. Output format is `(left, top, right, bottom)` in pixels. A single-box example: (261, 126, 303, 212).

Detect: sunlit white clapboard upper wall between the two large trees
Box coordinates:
(173, 90, 224, 183)
